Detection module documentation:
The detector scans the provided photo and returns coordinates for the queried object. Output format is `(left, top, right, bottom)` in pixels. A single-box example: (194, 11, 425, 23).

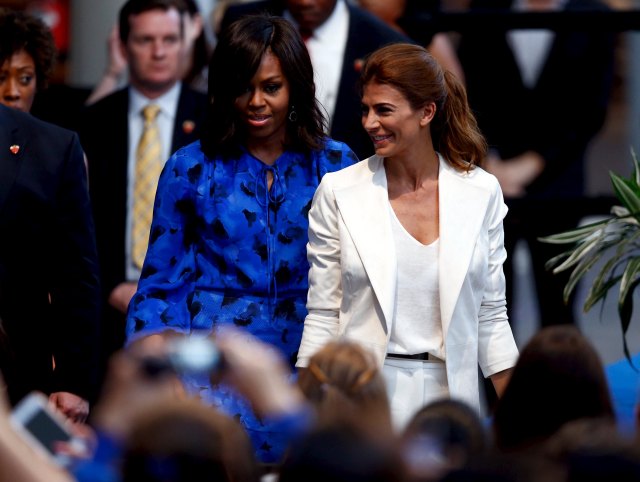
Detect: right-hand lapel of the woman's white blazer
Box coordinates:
(438, 157, 490, 338)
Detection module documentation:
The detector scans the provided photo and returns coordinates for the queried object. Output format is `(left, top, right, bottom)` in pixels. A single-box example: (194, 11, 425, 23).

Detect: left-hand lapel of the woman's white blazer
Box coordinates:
(335, 156, 397, 333)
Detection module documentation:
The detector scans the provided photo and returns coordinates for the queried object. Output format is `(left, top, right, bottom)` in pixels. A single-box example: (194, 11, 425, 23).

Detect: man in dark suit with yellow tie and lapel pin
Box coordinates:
(80, 0, 206, 388)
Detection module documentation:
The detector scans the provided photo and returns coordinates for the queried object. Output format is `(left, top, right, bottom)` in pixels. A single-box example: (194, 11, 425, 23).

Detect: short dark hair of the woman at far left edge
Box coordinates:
(0, 8, 57, 90)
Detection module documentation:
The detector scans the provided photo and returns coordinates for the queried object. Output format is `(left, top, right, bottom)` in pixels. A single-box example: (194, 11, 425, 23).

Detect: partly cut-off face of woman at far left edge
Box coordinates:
(0, 50, 36, 112)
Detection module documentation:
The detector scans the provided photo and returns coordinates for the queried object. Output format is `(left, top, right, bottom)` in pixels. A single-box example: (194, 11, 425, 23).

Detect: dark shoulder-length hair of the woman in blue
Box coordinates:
(201, 14, 326, 157)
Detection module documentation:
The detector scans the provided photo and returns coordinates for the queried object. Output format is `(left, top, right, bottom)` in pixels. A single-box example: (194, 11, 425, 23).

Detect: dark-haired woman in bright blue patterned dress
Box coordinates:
(127, 16, 357, 462)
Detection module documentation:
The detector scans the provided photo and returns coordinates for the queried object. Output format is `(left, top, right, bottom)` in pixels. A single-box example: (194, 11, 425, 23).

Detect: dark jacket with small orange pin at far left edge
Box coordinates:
(0, 106, 100, 402)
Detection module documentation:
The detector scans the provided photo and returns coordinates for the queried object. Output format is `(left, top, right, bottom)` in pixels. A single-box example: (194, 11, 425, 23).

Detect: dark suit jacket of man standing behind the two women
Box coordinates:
(220, 0, 412, 159)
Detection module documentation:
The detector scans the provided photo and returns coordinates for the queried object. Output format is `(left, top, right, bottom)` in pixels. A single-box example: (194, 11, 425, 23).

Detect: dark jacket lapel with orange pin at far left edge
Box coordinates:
(0, 107, 27, 217)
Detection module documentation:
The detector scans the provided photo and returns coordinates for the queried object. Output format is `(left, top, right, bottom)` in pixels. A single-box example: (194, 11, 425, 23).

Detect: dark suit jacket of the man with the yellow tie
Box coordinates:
(79, 85, 207, 372)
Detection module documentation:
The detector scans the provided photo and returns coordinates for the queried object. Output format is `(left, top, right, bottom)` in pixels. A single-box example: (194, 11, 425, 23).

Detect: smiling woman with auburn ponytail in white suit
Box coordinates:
(297, 44, 518, 427)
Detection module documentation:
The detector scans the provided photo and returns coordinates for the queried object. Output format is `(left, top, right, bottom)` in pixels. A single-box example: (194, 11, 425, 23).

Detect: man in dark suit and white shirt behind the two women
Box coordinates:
(220, 0, 411, 159)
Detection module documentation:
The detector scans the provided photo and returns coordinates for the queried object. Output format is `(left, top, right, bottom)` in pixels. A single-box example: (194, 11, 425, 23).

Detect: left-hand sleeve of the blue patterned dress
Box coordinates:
(126, 148, 204, 343)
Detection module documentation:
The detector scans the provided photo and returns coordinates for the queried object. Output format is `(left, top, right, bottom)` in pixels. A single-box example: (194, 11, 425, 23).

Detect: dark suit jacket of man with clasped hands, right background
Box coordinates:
(458, 0, 614, 198)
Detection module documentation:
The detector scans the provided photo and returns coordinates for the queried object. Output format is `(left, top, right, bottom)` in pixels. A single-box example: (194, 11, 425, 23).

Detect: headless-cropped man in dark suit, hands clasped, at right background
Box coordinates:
(458, 0, 614, 326)
